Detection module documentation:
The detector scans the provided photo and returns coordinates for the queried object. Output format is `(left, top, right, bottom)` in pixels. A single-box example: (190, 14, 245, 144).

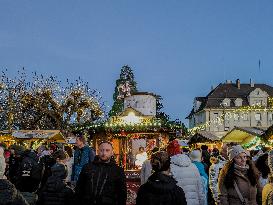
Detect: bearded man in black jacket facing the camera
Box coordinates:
(76, 142, 127, 205)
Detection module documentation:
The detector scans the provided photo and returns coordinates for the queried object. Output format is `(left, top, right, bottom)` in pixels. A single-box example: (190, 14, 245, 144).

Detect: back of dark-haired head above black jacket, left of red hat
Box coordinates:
(151, 151, 171, 172)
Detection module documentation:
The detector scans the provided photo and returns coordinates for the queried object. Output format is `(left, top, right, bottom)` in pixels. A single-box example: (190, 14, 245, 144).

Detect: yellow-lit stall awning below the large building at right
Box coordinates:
(222, 127, 265, 144)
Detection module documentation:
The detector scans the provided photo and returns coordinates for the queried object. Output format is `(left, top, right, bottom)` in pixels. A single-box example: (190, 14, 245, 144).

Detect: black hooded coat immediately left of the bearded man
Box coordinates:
(38, 163, 74, 205)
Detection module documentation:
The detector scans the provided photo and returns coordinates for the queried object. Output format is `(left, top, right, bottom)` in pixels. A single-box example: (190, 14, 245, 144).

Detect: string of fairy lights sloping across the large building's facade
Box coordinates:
(188, 97, 273, 135)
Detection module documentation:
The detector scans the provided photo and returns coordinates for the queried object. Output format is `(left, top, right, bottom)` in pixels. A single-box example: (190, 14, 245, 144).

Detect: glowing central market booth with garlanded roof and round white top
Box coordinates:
(75, 93, 181, 170)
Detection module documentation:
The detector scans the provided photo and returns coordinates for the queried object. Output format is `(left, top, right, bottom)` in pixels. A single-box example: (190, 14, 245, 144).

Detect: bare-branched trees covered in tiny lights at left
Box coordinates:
(0, 69, 104, 130)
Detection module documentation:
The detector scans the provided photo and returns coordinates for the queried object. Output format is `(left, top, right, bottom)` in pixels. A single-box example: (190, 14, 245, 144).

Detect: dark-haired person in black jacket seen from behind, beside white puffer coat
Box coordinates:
(136, 151, 187, 205)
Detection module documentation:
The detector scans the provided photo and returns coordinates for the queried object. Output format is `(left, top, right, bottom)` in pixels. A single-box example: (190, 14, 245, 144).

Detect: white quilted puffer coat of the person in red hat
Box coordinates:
(171, 154, 205, 205)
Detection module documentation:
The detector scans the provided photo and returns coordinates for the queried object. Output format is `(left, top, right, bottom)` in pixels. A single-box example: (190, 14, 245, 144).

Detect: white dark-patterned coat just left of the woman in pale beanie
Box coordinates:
(209, 160, 226, 201)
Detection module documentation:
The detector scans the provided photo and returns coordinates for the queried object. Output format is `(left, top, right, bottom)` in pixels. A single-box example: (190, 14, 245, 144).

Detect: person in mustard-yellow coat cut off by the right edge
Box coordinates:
(262, 150, 273, 205)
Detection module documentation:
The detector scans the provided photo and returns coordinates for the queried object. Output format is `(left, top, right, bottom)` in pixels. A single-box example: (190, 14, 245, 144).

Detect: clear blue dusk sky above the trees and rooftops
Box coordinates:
(0, 0, 273, 125)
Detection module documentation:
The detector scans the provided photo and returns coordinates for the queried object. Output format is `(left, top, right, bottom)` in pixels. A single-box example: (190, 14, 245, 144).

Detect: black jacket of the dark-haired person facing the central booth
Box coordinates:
(136, 173, 187, 205)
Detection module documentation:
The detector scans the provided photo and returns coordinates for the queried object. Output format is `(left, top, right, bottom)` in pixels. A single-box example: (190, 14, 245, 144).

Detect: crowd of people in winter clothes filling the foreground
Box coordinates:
(0, 136, 273, 205)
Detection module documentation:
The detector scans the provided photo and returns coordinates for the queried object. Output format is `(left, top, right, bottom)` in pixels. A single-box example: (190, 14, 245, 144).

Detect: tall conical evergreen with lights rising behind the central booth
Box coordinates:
(109, 65, 137, 117)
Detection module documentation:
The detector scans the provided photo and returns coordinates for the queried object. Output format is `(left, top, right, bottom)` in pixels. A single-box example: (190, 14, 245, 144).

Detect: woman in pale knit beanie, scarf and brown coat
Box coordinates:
(218, 145, 262, 205)
